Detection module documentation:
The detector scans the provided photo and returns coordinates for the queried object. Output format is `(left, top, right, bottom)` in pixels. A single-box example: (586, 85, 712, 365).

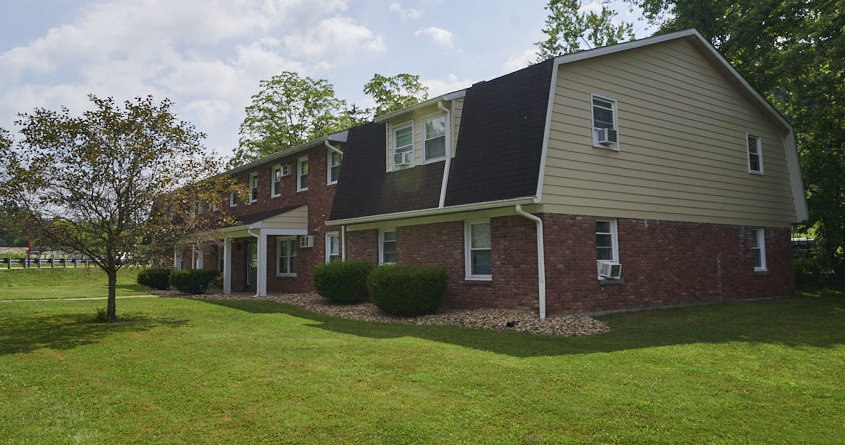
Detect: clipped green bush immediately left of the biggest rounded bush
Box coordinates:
(314, 260, 373, 303)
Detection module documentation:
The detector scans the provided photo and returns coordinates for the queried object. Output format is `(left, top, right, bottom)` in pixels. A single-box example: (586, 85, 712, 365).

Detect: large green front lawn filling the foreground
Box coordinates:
(0, 293, 845, 444)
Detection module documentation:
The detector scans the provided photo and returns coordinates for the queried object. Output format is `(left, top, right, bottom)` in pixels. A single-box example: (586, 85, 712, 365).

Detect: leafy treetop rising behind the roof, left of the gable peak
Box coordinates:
(535, 0, 634, 62)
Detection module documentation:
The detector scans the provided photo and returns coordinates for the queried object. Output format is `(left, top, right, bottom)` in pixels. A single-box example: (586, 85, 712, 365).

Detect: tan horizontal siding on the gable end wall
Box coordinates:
(542, 40, 796, 227)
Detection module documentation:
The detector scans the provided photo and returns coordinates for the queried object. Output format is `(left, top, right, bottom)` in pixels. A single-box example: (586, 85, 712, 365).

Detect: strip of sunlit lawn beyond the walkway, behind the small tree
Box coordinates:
(0, 267, 150, 300)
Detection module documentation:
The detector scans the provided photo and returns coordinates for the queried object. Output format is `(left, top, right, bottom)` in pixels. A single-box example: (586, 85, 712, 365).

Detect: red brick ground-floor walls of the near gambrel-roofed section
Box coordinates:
(346, 214, 794, 314)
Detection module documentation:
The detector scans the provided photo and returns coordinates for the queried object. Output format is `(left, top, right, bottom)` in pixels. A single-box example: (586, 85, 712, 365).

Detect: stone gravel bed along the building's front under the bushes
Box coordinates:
(154, 291, 610, 336)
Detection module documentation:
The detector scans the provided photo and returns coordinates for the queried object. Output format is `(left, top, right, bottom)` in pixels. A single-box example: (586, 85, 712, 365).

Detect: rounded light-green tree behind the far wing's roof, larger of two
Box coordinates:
(229, 71, 349, 167)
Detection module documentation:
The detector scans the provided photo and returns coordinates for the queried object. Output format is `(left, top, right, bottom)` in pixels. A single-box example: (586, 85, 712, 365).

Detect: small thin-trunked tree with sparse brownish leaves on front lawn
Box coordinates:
(0, 95, 237, 320)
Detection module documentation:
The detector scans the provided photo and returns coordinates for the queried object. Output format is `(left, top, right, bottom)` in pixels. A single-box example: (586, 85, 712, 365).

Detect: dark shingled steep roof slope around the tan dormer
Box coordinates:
(331, 59, 553, 220)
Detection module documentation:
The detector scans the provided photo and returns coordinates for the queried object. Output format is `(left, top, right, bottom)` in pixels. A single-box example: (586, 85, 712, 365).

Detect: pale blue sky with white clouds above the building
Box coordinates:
(0, 0, 650, 157)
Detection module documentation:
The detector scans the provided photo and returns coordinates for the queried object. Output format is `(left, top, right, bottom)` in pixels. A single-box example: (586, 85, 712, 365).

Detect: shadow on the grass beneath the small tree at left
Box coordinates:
(0, 313, 188, 355)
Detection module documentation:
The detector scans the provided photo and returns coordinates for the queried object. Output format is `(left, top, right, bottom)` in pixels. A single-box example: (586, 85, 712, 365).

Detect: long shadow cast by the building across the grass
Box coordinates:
(201, 293, 845, 357)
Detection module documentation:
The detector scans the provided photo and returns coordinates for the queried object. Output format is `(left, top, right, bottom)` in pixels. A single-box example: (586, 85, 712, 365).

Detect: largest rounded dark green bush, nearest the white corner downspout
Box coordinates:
(367, 264, 446, 315)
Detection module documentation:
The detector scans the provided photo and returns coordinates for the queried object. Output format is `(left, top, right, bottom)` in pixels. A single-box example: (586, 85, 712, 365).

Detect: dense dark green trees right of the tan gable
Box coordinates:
(629, 0, 845, 279)
